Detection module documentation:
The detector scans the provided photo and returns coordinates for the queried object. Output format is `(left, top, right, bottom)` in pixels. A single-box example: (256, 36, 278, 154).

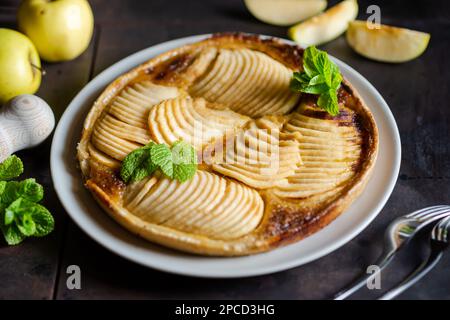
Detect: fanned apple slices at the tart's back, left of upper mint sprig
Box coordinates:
(189, 49, 299, 117)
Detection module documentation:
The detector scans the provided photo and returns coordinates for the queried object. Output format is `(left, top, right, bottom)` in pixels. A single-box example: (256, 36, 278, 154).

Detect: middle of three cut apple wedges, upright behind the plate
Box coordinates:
(289, 0, 358, 48)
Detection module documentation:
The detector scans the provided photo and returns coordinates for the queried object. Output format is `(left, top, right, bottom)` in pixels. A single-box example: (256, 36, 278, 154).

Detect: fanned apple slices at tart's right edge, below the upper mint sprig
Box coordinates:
(274, 104, 362, 198)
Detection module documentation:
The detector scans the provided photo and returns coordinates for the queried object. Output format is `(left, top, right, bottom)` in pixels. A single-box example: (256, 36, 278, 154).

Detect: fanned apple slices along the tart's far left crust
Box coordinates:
(90, 81, 179, 167)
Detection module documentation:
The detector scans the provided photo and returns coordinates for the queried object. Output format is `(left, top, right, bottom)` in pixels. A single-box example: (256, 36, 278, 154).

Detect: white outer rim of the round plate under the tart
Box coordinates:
(50, 34, 401, 278)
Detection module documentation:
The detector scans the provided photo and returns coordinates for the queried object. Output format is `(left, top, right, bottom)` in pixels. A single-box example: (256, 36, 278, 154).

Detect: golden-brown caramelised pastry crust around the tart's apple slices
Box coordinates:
(78, 33, 378, 256)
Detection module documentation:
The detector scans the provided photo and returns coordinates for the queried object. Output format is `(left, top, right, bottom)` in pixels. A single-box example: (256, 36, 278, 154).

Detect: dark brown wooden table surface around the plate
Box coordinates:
(0, 0, 450, 299)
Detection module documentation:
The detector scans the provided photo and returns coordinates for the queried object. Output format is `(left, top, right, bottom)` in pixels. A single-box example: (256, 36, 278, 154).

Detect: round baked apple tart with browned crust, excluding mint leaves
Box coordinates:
(78, 33, 378, 256)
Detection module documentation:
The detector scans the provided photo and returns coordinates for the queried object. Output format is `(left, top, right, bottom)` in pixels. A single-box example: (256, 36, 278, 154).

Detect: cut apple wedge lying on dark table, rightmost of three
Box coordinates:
(347, 21, 430, 63)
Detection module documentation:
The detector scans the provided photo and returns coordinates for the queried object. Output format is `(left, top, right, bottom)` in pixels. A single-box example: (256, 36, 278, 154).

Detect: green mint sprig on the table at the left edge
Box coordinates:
(0, 156, 55, 245)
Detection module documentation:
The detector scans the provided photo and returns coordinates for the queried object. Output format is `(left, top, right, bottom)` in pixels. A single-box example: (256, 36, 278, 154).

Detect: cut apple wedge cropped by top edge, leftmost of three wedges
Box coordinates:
(245, 0, 327, 26)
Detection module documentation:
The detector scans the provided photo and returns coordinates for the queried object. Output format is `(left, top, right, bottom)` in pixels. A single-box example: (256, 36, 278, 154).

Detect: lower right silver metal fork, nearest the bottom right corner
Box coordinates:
(379, 216, 450, 300)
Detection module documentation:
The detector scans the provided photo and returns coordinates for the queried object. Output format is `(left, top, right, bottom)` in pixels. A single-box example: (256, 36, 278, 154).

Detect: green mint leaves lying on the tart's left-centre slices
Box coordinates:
(120, 141, 197, 183)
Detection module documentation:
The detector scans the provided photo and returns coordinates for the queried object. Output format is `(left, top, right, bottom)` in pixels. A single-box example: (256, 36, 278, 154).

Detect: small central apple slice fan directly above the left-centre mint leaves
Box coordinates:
(148, 97, 250, 149)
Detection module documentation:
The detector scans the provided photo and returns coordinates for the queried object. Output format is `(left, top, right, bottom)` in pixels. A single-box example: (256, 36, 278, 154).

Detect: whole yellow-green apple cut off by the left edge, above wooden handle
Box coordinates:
(0, 28, 41, 104)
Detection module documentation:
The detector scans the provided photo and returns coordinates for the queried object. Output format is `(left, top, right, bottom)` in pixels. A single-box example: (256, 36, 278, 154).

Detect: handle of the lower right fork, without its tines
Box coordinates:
(378, 249, 443, 300)
